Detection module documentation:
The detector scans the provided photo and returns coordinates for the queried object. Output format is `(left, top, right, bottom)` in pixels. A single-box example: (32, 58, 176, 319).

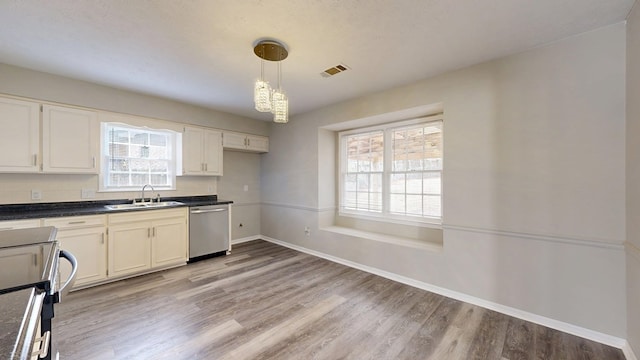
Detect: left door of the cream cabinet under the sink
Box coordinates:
(109, 222, 151, 277)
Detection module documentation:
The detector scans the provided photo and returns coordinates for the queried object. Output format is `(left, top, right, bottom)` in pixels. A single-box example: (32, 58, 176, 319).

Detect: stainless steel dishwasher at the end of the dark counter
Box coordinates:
(189, 204, 231, 262)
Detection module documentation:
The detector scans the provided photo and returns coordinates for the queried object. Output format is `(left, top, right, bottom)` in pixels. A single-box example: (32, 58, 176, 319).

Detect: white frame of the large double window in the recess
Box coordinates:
(338, 115, 444, 227)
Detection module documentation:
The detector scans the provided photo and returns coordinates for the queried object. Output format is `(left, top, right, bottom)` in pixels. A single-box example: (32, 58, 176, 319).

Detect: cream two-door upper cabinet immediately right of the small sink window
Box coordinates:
(182, 127, 222, 176)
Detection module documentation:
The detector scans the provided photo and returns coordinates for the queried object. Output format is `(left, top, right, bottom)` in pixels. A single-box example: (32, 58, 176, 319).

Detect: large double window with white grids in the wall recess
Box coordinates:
(339, 117, 442, 224)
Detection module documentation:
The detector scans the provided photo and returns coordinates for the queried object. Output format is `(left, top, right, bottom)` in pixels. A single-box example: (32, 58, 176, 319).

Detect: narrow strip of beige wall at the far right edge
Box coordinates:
(626, 2, 640, 354)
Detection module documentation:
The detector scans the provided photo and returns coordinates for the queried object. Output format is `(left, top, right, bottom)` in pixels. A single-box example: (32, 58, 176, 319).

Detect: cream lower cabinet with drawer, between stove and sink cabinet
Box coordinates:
(42, 215, 107, 288)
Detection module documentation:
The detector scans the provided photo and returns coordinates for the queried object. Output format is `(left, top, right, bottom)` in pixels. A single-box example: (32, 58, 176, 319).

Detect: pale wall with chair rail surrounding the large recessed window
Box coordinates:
(261, 23, 626, 338)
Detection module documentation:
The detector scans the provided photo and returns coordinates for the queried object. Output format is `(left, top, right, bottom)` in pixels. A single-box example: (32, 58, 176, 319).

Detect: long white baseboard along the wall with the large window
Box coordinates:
(257, 236, 637, 352)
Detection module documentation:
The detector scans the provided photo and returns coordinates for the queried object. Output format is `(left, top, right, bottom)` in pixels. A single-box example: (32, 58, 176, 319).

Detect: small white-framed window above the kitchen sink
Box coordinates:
(100, 123, 178, 191)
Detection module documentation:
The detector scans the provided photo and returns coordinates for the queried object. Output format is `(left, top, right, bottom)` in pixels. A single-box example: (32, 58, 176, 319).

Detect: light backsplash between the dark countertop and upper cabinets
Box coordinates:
(0, 174, 218, 204)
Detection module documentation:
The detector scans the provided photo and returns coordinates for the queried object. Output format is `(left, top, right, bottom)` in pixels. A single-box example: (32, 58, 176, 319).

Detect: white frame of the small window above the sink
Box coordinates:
(98, 122, 180, 192)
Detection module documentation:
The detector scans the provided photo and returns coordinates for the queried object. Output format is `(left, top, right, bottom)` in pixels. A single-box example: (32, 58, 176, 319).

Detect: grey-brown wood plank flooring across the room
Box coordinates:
(54, 241, 624, 360)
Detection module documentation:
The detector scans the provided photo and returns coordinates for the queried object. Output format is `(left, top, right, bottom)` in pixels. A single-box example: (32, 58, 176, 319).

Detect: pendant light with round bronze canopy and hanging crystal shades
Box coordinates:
(253, 40, 289, 123)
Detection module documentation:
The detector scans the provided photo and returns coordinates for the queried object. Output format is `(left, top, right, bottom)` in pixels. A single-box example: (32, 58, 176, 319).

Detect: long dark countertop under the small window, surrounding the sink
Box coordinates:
(0, 195, 233, 220)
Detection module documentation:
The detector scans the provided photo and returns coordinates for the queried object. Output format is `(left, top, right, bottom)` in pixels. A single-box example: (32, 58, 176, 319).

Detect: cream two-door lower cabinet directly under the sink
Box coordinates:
(109, 208, 188, 277)
